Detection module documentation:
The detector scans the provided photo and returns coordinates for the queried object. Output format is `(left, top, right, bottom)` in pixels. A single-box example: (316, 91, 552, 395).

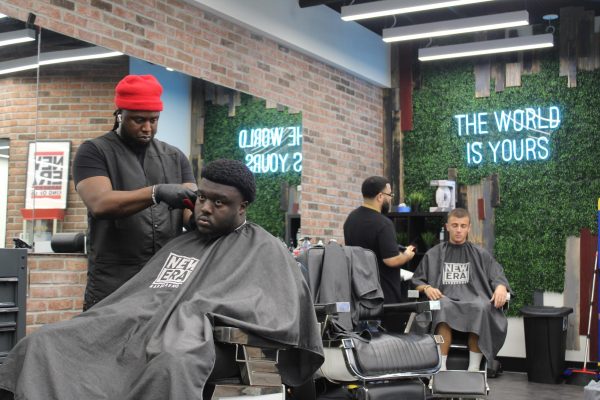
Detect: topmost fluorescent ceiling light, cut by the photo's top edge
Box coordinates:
(341, 0, 495, 21)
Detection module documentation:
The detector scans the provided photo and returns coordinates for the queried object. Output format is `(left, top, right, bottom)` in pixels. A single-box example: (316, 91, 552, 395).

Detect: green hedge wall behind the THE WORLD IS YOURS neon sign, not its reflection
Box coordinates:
(404, 52, 600, 315)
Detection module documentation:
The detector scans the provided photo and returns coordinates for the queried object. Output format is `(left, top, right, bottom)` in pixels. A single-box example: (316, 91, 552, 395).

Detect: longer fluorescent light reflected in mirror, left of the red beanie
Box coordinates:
(0, 46, 123, 75)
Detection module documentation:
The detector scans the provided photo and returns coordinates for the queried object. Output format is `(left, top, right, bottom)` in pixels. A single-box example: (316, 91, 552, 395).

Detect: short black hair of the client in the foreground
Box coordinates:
(200, 159, 256, 203)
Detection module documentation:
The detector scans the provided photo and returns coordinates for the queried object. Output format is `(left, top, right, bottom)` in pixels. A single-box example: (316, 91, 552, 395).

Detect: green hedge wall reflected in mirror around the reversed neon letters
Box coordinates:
(204, 94, 302, 238)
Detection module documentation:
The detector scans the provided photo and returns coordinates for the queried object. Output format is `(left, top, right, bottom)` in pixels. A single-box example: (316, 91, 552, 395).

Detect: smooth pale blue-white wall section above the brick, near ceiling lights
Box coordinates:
(187, 0, 391, 88)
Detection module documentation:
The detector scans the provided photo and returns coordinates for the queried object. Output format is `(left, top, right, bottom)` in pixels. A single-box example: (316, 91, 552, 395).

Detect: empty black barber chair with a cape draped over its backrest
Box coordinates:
(298, 244, 441, 400)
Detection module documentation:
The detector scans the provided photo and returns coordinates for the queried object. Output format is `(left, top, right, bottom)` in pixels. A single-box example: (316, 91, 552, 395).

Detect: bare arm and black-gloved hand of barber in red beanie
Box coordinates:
(76, 176, 196, 219)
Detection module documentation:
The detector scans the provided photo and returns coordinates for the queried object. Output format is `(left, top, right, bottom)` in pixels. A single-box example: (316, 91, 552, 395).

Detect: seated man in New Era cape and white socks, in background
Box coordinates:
(412, 208, 510, 371)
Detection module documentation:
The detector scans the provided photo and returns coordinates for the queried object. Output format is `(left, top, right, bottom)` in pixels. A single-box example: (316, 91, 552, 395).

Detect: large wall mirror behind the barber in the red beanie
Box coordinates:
(0, 18, 302, 253)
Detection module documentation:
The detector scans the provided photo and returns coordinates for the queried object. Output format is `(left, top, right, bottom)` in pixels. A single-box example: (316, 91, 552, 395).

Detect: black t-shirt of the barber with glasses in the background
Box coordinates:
(344, 206, 401, 303)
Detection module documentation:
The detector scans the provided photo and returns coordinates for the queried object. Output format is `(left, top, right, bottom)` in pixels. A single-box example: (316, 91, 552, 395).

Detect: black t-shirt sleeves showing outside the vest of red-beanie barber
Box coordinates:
(73, 142, 196, 186)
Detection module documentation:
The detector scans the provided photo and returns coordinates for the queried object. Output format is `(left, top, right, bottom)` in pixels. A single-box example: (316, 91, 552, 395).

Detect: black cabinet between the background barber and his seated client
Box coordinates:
(387, 211, 448, 271)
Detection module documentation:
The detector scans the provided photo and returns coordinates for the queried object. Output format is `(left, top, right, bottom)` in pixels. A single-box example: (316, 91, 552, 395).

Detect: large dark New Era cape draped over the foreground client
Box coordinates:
(0, 223, 323, 400)
